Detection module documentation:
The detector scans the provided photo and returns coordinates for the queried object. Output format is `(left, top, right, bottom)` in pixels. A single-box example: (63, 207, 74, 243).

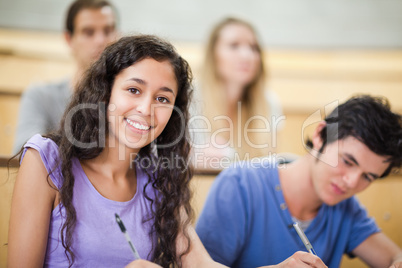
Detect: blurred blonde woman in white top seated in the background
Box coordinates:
(195, 18, 283, 166)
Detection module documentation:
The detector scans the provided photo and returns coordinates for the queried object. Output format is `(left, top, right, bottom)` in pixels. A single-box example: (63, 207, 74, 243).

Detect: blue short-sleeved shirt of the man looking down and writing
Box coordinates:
(196, 162, 379, 268)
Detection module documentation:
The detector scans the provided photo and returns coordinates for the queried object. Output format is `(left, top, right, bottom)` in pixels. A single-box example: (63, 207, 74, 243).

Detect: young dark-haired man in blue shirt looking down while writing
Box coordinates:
(196, 96, 402, 268)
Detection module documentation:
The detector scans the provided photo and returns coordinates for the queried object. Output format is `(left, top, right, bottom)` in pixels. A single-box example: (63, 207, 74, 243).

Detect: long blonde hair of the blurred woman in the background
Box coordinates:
(200, 17, 272, 158)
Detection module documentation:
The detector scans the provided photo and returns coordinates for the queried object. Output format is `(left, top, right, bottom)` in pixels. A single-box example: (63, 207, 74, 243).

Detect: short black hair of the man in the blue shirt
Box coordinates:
(306, 95, 402, 177)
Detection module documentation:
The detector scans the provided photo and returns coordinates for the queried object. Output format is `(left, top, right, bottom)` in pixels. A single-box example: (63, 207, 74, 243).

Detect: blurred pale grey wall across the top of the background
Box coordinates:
(0, 0, 402, 48)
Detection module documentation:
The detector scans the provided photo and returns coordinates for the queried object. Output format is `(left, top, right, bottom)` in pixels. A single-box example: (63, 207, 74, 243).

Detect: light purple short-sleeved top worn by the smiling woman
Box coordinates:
(24, 135, 156, 267)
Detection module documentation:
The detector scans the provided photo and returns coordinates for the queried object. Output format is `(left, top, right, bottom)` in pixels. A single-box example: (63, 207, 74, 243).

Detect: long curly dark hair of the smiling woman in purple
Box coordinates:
(48, 35, 193, 267)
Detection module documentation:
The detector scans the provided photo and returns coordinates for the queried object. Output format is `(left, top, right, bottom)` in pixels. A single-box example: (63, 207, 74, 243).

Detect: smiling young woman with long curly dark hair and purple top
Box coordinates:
(8, 35, 226, 267)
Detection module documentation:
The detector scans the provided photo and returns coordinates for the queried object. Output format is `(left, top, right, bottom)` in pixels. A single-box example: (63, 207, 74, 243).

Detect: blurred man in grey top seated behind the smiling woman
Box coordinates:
(13, 0, 118, 153)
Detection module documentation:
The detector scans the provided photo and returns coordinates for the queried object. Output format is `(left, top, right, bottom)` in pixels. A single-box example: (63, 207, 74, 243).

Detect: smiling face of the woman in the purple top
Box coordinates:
(108, 58, 178, 151)
